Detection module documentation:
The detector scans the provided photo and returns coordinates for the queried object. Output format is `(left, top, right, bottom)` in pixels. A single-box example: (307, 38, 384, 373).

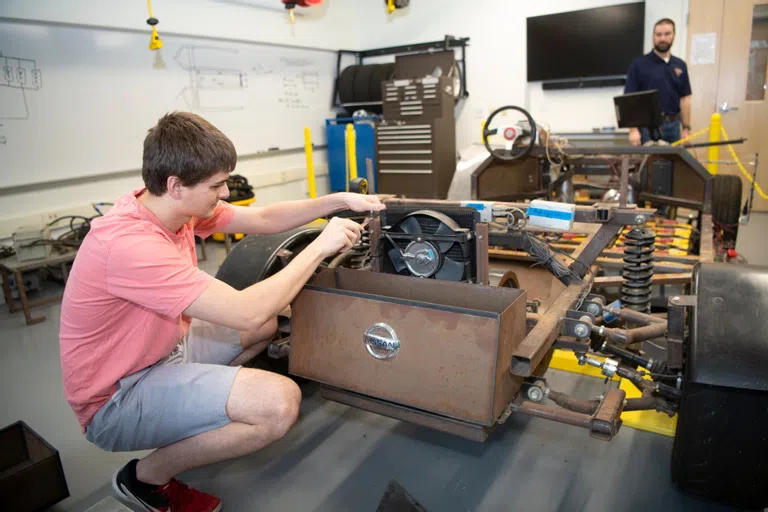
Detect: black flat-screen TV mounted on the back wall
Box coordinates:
(527, 2, 645, 82)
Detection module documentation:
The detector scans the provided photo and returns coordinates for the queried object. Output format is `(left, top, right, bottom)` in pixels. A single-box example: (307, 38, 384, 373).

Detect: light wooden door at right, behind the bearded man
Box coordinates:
(688, 0, 768, 211)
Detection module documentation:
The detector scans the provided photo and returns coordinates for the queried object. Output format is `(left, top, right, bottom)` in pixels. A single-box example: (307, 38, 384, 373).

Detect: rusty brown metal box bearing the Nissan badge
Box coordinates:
(289, 269, 526, 427)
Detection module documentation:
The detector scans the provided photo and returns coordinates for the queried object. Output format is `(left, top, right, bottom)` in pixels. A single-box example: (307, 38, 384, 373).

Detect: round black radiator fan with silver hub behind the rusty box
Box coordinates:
(382, 210, 471, 281)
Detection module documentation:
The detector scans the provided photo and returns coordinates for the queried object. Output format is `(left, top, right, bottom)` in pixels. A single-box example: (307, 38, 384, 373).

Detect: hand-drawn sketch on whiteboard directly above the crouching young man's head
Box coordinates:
(174, 45, 248, 112)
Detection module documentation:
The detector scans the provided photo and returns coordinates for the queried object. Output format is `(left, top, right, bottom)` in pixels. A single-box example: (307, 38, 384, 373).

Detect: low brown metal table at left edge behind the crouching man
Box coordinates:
(0, 250, 77, 325)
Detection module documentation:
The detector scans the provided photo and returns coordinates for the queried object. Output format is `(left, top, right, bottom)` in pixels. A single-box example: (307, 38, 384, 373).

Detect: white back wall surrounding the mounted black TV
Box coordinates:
(362, 0, 688, 140)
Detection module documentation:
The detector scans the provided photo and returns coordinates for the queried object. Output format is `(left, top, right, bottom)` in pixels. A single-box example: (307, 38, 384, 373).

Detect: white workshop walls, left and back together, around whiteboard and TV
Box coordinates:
(0, 0, 688, 239)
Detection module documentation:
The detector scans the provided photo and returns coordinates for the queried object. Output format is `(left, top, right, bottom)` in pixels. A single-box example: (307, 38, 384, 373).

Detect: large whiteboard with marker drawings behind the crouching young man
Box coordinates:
(0, 21, 336, 189)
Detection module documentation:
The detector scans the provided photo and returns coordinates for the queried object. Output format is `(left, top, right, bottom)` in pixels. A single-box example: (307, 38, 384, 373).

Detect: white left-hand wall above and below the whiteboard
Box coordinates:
(0, 0, 352, 240)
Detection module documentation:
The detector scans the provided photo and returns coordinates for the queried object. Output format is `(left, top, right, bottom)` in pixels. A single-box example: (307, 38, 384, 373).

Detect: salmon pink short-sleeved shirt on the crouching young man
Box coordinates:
(59, 189, 234, 427)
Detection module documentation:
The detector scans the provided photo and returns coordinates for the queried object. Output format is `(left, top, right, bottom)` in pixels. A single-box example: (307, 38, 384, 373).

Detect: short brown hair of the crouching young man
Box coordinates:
(141, 112, 237, 196)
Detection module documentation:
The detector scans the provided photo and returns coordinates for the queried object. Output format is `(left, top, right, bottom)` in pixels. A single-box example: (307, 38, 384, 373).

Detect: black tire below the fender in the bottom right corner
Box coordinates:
(672, 382, 768, 510)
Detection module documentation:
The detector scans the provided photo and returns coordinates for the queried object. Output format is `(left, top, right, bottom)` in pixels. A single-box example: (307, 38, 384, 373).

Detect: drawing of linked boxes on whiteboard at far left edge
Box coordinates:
(0, 52, 43, 121)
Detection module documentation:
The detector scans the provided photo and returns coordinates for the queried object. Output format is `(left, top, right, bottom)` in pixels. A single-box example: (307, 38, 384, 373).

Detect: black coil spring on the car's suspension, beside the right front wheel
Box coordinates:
(621, 228, 656, 313)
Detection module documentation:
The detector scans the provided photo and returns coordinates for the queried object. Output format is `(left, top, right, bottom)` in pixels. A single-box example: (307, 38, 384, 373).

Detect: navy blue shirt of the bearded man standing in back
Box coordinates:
(624, 51, 691, 114)
